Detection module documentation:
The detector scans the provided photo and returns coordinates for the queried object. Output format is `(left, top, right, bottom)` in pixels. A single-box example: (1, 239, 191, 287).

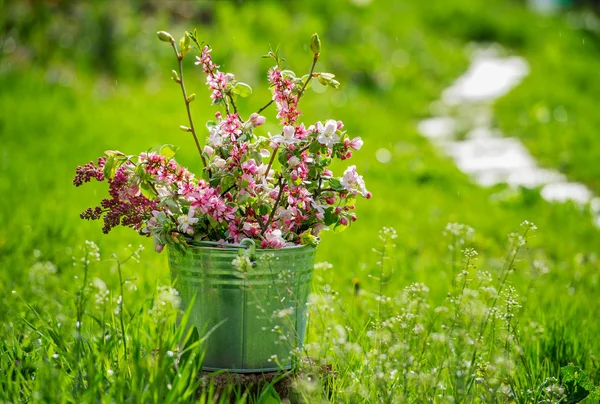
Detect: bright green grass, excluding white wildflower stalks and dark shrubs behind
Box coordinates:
(0, 1, 600, 402)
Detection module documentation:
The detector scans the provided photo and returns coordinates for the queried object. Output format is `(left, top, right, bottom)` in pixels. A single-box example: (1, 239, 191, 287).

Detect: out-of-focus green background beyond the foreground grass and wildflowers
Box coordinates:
(0, 0, 600, 310)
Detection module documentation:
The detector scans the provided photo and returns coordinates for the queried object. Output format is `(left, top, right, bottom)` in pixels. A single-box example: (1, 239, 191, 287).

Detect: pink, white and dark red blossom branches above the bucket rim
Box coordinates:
(74, 34, 371, 251)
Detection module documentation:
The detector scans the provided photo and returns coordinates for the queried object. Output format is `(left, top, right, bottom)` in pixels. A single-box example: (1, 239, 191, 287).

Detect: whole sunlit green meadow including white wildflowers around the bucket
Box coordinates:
(0, 0, 600, 403)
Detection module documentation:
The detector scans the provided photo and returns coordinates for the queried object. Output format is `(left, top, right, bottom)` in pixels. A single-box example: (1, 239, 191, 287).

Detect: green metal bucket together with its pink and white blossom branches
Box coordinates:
(74, 31, 371, 371)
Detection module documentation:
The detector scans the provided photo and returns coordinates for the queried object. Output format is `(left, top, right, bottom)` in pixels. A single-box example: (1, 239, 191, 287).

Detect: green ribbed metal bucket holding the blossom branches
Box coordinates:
(169, 240, 315, 373)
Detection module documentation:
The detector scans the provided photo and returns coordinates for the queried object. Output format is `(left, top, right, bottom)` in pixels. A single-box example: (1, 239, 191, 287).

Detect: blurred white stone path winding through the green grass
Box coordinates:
(418, 46, 600, 227)
